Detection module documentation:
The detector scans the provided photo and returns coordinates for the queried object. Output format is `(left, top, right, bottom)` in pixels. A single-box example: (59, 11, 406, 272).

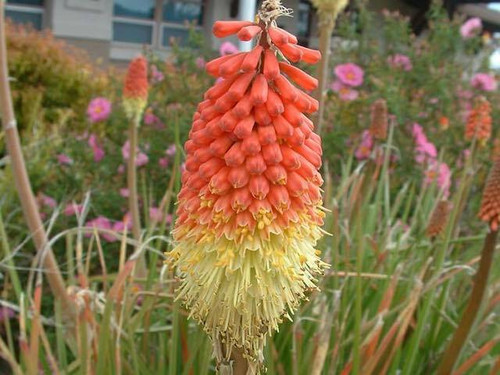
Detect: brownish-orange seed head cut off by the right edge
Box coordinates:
(479, 158, 500, 230)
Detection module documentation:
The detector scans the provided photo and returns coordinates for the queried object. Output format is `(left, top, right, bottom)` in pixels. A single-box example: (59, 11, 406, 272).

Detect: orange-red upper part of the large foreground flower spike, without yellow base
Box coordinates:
(177, 21, 322, 238)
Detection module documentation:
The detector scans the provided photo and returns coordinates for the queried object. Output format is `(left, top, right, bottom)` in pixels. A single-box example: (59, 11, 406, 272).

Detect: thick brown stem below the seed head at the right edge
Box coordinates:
(437, 231, 498, 375)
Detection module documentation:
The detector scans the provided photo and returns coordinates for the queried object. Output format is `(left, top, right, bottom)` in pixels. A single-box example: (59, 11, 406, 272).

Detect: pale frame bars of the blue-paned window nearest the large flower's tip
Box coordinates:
(112, 0, 205, 50)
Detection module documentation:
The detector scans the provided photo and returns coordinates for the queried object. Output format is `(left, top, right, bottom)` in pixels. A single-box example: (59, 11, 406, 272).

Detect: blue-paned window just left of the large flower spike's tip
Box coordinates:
(113, 0, 203, 48)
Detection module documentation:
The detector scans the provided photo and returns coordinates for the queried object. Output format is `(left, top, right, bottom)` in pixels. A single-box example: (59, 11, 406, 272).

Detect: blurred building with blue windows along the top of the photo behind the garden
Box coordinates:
(6, 0, 500, 62)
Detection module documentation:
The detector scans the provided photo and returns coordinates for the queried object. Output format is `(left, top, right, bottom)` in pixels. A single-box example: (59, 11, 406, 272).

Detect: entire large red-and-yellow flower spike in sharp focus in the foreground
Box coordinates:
(167, 0, 327, 374)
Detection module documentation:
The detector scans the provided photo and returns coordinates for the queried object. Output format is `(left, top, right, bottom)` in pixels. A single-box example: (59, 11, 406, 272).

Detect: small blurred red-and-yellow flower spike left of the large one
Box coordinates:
(123, 56, 148, 121)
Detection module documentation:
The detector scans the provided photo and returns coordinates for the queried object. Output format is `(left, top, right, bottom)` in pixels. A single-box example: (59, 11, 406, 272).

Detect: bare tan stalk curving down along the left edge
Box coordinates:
(0, 1, 76, 320)
